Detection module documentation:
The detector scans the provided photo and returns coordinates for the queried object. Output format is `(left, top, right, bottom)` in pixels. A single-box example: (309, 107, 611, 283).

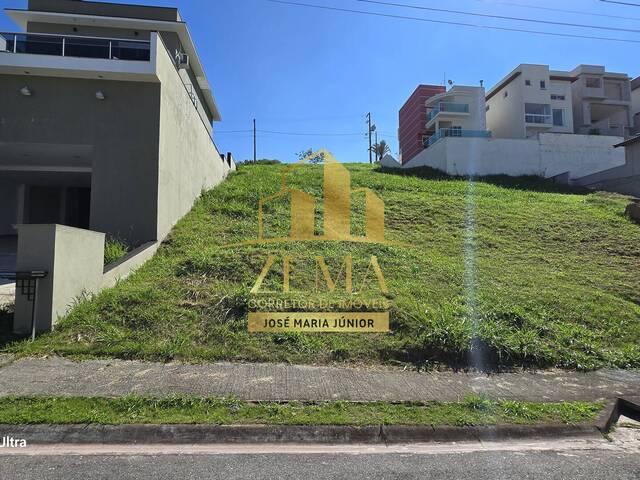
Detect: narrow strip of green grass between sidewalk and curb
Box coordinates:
(0, 396, 603, 426)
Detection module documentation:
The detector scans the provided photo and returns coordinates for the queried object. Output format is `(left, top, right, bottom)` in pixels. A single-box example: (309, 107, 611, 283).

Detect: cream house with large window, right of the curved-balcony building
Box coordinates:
(486, 64, 574, 138)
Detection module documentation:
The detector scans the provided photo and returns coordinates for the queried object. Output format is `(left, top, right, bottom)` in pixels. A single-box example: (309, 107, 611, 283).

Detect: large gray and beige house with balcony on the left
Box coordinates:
(0, 0, 234, 245)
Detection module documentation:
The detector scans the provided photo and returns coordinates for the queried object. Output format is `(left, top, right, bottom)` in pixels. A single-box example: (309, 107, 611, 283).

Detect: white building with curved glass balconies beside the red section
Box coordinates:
(424, 85, 491, 147)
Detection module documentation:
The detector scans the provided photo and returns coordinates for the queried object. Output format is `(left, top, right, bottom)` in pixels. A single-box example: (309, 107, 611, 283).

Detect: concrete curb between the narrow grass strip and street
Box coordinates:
(0, 399, 640, 445)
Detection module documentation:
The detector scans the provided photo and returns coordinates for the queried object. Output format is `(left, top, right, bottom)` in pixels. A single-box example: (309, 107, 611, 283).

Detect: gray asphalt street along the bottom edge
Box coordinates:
(0, 429, 640, 480)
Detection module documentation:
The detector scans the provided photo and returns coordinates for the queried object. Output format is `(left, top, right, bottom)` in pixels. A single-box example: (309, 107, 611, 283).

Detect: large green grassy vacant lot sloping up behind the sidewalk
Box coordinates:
(2, 164, 640, 368)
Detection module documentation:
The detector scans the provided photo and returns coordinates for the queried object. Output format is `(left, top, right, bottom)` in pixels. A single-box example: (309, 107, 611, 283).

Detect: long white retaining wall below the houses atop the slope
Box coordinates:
(404, 133, 625, 179)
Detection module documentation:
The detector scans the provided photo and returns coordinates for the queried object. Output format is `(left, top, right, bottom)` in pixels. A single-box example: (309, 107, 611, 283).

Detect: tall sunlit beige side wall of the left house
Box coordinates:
(157, 34, 229, 239)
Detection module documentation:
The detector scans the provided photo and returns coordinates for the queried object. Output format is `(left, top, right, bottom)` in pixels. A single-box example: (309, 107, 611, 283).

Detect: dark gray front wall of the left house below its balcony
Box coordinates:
(0, 75, 160, 245)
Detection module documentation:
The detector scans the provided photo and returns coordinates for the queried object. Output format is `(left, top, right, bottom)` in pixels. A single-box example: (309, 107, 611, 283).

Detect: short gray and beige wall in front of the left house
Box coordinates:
(13, 225, 104, 334)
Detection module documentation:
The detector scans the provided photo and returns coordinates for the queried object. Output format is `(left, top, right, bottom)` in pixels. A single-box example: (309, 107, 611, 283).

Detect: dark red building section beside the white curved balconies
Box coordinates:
(398, 85, 446, 164)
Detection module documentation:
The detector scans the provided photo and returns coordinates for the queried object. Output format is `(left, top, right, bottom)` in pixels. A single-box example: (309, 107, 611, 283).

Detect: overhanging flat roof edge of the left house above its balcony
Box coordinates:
(5, 8, 221, 121)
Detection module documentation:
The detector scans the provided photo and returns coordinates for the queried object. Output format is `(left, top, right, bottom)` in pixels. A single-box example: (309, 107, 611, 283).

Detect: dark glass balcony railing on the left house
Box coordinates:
(0, 33, 151, 62)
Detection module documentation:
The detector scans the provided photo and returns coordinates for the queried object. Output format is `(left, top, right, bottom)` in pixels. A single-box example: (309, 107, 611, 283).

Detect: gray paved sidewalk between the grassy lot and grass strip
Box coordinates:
(0, 358, 640, 402)
